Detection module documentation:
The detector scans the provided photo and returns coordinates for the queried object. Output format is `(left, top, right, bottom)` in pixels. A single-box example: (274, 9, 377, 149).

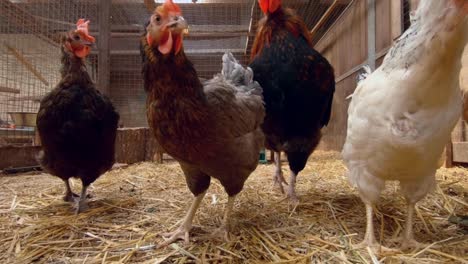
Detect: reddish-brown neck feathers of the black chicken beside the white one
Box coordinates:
(250, 7, 313, 60)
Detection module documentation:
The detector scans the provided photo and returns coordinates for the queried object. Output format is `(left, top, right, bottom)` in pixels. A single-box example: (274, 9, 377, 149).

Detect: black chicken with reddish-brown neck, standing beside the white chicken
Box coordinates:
(250, 0, 335, 202)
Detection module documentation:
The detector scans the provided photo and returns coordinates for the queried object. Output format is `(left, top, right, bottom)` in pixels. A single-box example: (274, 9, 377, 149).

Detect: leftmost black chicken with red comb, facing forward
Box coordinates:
(37, 19, 119, 213)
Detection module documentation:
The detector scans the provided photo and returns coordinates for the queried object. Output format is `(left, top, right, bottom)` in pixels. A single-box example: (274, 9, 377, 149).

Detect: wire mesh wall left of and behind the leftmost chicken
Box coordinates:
(0, 0, 96, 144)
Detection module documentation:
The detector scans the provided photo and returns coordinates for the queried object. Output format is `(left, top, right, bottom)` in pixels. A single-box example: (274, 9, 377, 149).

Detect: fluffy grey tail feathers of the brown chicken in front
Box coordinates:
(221, 52, 262, 95)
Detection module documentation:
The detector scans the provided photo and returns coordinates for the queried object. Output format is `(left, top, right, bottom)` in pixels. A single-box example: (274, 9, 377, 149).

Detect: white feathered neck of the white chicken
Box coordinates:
(382, 0, 468, 71)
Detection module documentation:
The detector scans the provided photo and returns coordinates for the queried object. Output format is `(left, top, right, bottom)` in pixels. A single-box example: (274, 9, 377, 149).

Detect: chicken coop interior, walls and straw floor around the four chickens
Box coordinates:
(0, 0, 468, 263)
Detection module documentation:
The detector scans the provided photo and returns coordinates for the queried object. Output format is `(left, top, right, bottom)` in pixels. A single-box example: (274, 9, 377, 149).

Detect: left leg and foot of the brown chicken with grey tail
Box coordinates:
(158, 191, 206, 248)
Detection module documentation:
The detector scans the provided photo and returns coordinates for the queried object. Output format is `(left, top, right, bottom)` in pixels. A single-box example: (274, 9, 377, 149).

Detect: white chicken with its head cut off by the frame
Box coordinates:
(342, 0, 468, 249)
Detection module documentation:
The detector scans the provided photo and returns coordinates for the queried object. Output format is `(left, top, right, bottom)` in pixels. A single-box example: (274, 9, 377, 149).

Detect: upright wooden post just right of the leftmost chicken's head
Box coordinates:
(97, 0, 111, 94)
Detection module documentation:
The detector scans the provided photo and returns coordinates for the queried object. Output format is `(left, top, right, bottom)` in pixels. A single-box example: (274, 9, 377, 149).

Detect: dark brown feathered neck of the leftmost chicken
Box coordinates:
(60, 46, 92, 83)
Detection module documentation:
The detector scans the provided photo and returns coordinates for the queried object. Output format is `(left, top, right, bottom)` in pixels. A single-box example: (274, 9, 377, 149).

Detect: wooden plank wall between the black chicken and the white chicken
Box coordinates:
(315, 0, 402, 151)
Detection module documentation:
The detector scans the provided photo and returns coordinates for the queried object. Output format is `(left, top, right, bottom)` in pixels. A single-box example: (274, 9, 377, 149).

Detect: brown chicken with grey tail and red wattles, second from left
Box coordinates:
(141, 0, 265, 246)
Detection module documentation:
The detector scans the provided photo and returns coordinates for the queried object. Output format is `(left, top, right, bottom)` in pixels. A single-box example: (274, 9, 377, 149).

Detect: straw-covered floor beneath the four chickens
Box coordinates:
(0, 151, 468, 263)
